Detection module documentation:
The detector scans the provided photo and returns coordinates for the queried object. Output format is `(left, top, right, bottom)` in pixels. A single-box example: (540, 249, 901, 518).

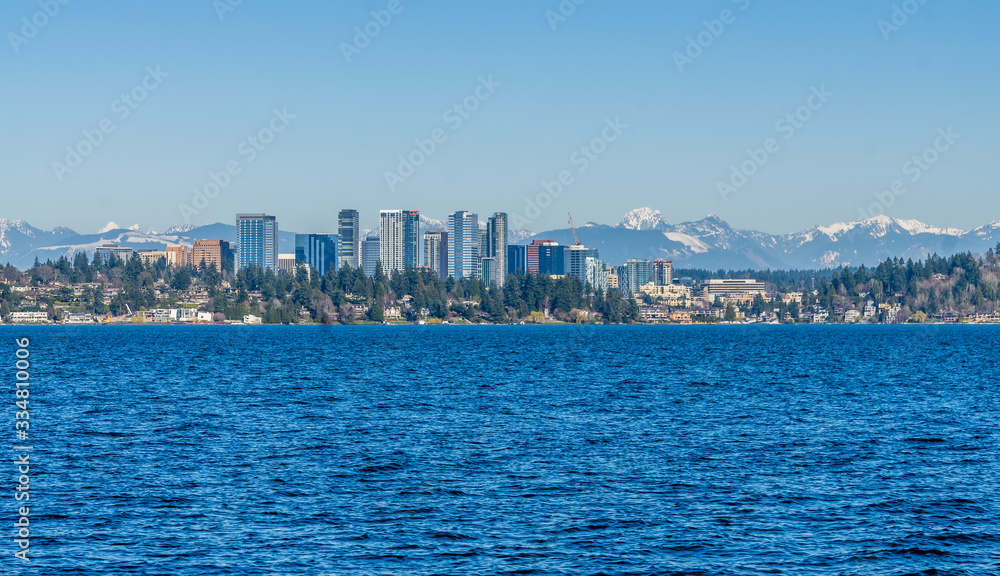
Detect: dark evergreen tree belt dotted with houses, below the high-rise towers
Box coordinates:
(0, 252, 638, 323)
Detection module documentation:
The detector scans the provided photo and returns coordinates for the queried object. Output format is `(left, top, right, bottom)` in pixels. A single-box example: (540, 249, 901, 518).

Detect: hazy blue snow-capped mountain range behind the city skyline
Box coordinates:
(0, 208, 1000, 270)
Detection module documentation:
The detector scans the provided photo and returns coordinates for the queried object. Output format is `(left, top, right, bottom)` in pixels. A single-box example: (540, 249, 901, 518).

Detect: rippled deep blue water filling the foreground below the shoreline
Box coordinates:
(9, 326, 1000, 575)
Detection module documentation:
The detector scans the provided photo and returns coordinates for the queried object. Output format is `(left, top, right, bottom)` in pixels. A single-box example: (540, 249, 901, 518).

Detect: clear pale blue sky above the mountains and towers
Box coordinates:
(0, 0, 1000, 233)
